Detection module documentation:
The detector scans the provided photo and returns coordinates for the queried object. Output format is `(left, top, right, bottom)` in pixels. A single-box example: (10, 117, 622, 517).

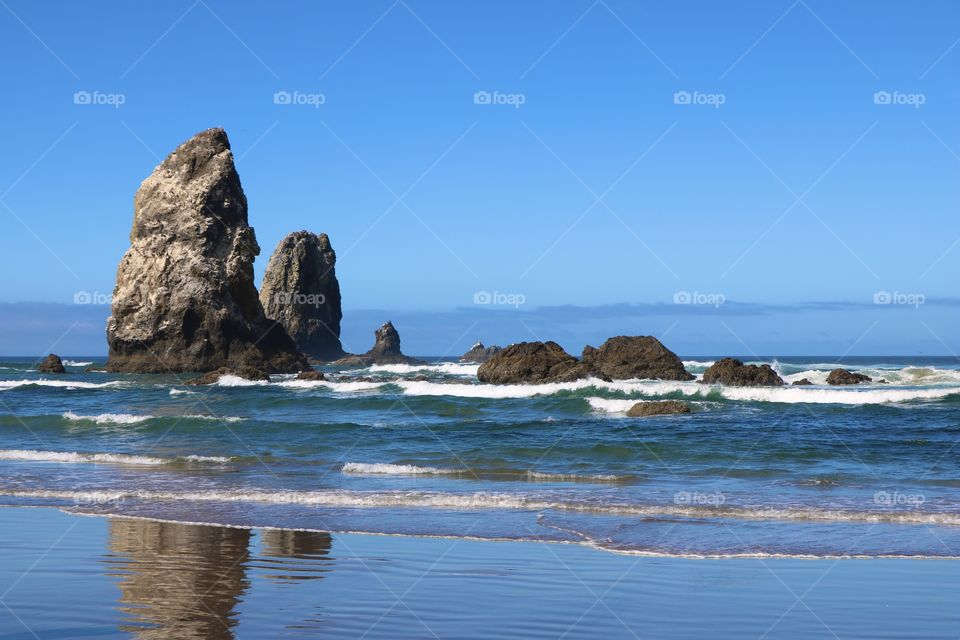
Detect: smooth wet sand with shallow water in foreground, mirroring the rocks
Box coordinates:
(0, 508, 960, 640)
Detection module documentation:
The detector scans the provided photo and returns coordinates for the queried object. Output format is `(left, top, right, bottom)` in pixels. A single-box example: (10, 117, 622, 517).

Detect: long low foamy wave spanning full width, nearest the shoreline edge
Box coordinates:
(9, 488, 960, 526)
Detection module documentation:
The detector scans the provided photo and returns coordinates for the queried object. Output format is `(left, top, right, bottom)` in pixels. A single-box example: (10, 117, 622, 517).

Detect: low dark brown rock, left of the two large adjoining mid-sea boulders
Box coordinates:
(477, 342, 589, 384)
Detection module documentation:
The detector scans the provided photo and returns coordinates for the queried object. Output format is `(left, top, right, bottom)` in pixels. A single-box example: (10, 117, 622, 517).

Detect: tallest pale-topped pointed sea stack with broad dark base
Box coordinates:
(107, 129, 309, 372)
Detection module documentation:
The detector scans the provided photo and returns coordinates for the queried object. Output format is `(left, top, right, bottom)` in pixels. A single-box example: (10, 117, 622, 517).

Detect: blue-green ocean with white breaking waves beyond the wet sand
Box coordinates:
(0, 357, 960, 558)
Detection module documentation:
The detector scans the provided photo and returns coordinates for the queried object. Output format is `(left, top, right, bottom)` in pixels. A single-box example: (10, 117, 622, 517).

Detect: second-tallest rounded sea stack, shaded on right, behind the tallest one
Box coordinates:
(260, 231, 344, 361)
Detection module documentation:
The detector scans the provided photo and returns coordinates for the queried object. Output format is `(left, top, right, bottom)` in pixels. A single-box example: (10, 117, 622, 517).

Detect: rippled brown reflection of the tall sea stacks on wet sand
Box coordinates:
(104, 519, 331, 640)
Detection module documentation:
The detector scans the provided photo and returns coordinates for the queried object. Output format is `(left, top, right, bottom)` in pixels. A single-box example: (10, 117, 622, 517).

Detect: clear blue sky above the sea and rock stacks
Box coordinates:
(0, 0, 960, 355)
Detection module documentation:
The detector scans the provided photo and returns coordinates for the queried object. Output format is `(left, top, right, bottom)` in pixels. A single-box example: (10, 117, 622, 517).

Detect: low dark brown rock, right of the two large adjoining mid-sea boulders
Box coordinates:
(580, 336, 694, 380)
